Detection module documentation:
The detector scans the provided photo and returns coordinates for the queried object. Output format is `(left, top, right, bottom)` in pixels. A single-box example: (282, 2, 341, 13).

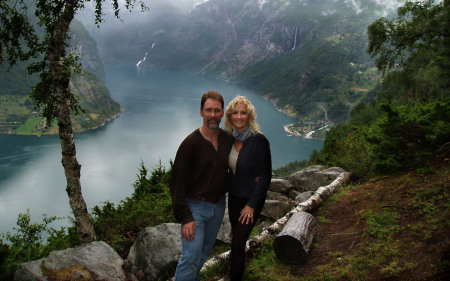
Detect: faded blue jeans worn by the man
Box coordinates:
(175, 196, 225, 281)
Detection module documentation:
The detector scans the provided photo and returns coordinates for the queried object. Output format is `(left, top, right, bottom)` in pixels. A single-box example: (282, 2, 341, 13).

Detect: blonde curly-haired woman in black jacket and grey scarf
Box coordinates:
(225, 96, 272, 280)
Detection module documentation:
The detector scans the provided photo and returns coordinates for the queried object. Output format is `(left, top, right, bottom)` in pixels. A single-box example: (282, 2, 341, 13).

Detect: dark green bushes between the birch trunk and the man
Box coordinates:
(92, 162, 175, 253)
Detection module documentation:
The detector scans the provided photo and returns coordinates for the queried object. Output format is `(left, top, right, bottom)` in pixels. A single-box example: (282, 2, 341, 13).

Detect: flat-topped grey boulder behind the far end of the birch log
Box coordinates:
(286, 165, 345, 192)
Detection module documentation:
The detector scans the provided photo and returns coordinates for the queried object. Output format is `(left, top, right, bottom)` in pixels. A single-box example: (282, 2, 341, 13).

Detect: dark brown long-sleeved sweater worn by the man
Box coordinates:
(170, 129, 233, 224)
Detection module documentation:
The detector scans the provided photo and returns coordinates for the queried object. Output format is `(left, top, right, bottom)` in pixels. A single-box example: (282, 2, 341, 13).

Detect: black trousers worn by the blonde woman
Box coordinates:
(228, 194, 262, 281)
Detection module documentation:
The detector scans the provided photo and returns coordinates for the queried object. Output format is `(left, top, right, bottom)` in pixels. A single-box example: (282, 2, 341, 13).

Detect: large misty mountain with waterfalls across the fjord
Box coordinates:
(81, 0, 403, 129)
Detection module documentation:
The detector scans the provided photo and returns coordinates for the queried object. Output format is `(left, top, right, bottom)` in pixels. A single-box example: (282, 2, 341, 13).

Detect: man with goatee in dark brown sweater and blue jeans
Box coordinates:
(170, 91, 233, 281)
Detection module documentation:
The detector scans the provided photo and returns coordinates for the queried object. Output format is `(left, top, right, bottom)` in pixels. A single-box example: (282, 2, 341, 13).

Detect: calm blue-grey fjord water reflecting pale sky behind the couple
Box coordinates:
(0, 64, 323, 233)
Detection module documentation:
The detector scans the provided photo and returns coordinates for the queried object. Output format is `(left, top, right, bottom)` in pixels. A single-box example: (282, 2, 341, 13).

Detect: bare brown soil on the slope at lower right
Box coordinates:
(291, 159, 450, 280)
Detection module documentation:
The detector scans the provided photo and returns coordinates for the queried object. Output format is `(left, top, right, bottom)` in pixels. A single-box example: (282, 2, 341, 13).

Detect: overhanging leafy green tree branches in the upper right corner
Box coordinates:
(367, 0, 450, 99)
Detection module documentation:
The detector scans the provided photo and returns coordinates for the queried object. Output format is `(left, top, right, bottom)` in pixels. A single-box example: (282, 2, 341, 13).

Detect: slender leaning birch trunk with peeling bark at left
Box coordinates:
(47, 0, 96, 243)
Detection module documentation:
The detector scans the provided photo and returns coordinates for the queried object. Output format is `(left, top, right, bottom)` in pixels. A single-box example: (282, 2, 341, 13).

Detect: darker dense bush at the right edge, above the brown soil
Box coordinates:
(366, 101, 450, 173)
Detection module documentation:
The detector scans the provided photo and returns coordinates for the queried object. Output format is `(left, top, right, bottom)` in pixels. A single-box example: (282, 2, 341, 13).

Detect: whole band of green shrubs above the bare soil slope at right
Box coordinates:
(310, 98, 450, 178)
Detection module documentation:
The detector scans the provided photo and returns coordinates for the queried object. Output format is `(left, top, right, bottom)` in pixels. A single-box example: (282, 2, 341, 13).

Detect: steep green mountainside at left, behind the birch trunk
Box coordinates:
(0, 20, 121, 134)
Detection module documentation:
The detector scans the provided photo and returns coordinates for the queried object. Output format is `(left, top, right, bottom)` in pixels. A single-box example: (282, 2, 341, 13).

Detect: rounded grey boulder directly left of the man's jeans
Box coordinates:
(127, 223, 181, 280)
